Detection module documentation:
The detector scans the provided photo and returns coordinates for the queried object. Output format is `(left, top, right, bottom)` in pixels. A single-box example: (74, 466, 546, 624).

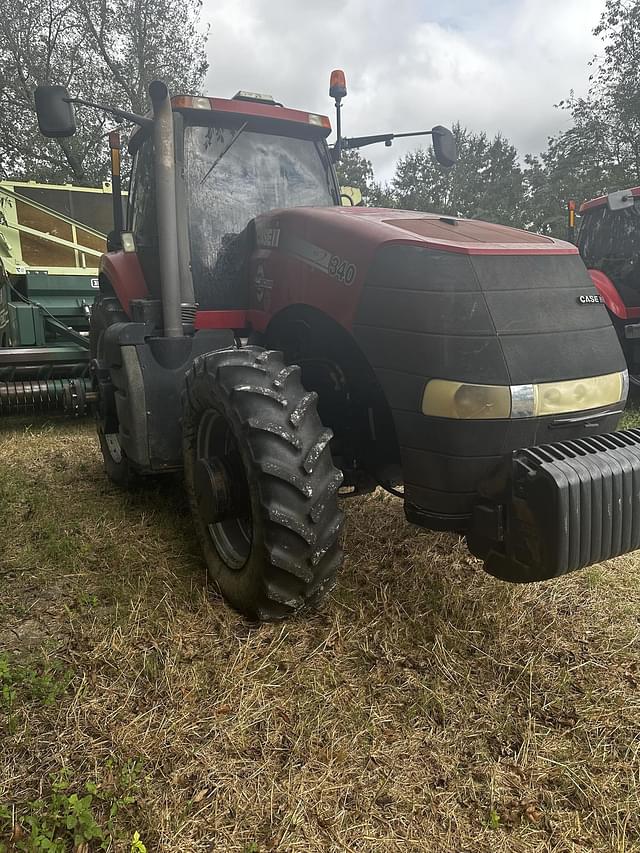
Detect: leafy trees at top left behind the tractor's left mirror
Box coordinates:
(0, 0, 207, 183)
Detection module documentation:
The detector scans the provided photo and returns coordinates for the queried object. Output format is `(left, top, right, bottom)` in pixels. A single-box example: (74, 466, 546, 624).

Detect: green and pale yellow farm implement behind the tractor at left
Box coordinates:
(0, 181, 112, 415)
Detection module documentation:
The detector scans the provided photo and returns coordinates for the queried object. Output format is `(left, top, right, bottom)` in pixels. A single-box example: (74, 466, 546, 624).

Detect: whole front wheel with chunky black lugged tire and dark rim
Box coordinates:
(183, 347, 343, 621)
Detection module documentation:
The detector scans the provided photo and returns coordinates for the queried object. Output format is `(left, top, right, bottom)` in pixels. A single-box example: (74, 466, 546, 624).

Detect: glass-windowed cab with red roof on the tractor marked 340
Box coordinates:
(128, 92, 340, 310)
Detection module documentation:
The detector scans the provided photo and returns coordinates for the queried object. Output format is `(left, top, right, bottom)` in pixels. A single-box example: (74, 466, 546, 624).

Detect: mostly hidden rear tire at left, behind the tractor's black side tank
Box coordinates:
(89, 294, 137, 489)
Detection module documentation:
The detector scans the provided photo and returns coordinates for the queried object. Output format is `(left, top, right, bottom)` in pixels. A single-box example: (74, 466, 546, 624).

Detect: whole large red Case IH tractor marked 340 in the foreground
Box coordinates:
(36, 73, 640, 619)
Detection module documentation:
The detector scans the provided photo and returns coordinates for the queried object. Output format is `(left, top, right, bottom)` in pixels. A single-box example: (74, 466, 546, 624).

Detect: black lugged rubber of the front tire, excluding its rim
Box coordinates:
(185, 346, 343, 620)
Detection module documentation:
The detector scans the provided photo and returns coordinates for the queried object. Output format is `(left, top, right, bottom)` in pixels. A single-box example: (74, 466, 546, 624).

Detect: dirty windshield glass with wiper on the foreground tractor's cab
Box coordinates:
(184, 120, 338, 308)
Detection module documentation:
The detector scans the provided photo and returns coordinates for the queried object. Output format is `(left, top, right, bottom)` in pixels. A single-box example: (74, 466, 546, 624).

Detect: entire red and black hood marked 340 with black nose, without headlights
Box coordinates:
(249, 208, 625, 529)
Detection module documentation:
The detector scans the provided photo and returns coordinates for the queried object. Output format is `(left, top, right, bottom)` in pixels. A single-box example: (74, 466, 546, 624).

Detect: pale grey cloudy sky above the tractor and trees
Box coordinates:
(204, 0, 604, 178)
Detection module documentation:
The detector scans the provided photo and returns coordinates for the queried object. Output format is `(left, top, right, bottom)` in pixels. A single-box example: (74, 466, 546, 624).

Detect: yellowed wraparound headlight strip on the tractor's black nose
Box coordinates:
(422, 370, 629, 420)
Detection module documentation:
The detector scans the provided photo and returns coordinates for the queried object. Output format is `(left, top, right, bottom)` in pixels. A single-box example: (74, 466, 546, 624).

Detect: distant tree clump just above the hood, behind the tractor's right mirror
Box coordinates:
(391, 124, 523, 224)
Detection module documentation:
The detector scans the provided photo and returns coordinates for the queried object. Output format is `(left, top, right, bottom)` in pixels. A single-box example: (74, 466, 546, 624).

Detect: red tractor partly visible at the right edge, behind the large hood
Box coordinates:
(577, 187, 640, 386)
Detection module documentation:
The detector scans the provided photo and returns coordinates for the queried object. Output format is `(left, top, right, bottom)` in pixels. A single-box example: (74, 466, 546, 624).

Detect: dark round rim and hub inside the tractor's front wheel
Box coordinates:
(195, 409, 253, 571)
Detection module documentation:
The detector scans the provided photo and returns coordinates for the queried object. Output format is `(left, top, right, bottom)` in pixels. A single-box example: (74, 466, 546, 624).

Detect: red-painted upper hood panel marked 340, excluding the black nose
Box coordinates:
(249, 207, 586, 331)
